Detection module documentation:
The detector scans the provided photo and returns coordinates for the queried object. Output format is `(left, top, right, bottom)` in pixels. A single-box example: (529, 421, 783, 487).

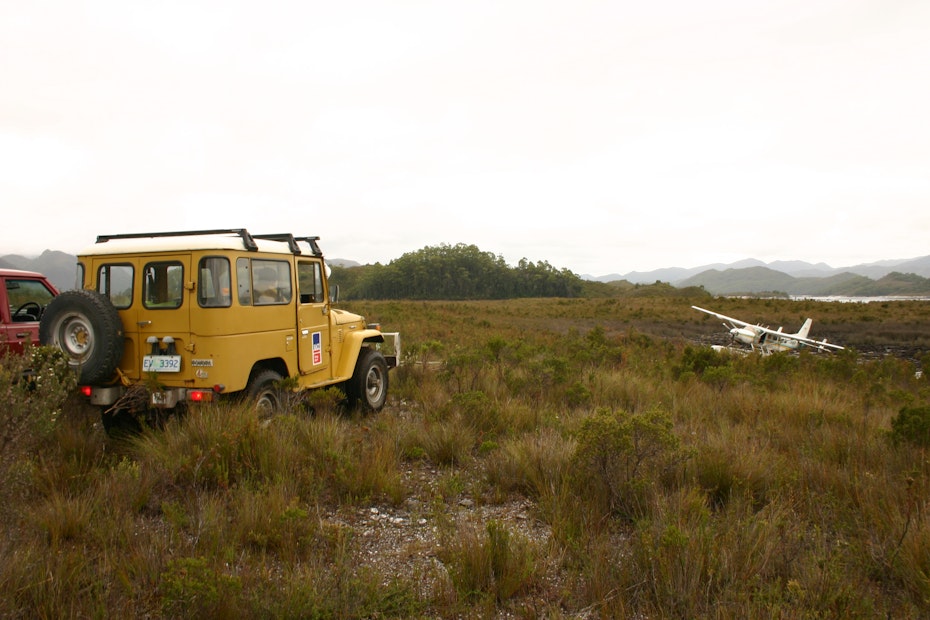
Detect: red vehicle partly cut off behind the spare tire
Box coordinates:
(0, 269, 58, 354)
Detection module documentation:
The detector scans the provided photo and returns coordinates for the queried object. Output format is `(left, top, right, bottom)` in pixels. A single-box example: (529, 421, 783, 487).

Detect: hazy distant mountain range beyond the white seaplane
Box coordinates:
(582, 256, 930, 297)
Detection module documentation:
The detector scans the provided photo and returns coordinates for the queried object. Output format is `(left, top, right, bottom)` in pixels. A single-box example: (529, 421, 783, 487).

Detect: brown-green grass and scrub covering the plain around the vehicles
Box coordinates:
(0, 298, 930, 618)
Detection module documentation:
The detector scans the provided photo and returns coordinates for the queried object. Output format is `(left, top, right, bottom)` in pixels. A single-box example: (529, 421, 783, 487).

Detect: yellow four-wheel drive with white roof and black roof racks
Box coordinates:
(39, 229, 400, 421)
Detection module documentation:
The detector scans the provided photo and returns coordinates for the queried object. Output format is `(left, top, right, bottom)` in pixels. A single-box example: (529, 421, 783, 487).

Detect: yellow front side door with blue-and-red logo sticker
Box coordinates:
(297, 258, 332, 381)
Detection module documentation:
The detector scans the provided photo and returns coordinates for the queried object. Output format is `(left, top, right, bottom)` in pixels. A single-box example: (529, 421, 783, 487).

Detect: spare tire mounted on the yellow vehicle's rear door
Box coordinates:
(39, 289, 123, 384)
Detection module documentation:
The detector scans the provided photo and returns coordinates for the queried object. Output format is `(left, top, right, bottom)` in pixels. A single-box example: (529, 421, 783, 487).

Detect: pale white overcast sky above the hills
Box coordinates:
(0, 0, 930, 275)
